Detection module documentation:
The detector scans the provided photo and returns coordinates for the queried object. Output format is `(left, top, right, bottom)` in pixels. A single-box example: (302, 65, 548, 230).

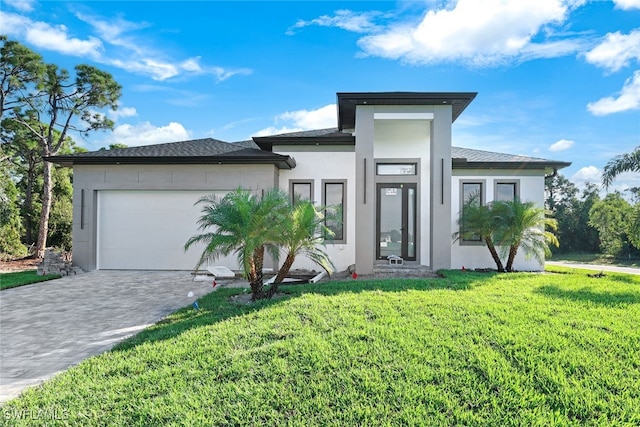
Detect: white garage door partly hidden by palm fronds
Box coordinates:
(98, 190, 236, 270)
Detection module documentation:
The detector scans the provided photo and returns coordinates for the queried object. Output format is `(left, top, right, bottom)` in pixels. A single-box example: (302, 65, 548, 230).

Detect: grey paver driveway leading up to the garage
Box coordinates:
(0, 271, 245, 403)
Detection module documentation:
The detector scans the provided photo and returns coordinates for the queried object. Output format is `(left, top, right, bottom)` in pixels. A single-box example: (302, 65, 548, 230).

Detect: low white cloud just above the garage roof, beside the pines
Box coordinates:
(105, 122, 191, 147)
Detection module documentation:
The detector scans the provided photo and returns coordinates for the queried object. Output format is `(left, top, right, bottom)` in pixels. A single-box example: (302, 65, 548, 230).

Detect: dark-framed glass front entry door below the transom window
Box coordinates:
(376, 184, 417, 261)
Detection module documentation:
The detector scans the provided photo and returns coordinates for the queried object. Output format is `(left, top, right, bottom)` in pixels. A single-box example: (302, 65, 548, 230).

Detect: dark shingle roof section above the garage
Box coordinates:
(47, 138, 295, 169)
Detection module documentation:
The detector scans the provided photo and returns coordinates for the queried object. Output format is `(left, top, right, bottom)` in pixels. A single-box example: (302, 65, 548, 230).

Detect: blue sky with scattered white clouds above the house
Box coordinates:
(0, 0, 640, 194)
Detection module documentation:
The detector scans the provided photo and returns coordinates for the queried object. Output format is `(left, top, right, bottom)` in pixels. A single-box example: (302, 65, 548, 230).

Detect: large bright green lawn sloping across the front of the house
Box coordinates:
(0, 268, 640, 426)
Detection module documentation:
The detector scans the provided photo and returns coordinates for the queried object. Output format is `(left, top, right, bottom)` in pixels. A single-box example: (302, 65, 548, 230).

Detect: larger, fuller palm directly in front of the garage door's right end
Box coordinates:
(184, 188, 288, 300)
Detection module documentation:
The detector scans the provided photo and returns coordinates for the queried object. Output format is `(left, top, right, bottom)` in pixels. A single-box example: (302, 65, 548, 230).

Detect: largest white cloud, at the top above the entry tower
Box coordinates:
(359, 0, 584, 66)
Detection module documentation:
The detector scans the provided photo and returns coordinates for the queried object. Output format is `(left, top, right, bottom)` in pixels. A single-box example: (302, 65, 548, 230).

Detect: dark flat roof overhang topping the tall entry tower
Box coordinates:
(337, 92, 477, 131)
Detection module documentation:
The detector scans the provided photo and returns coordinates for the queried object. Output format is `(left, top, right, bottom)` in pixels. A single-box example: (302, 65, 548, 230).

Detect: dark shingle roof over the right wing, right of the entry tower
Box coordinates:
(451, 147, 571, 169)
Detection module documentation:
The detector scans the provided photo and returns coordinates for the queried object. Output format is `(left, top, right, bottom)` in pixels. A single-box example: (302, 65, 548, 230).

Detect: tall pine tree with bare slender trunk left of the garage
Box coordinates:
(0, 37, 121, 257)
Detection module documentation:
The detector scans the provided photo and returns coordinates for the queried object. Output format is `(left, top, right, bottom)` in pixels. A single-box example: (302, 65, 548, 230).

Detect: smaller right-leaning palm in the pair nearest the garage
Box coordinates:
(267, 199, 335, 296)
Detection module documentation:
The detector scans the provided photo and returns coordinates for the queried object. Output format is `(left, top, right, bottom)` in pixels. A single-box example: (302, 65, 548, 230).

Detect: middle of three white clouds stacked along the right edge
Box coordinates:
(585, 29, 640, 72)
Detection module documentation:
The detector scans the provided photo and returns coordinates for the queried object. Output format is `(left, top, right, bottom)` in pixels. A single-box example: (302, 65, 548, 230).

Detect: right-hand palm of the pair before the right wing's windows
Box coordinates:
(491, 199, 558, 271)
